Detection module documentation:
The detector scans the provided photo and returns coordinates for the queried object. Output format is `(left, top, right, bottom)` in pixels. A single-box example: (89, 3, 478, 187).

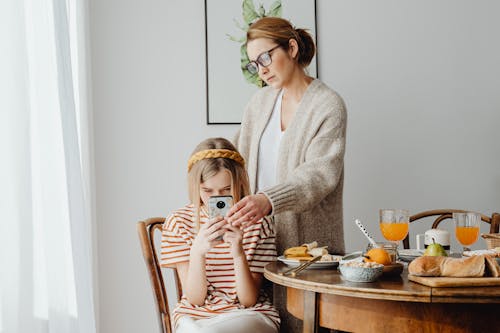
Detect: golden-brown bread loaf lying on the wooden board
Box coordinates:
(408, 255, 500, 277)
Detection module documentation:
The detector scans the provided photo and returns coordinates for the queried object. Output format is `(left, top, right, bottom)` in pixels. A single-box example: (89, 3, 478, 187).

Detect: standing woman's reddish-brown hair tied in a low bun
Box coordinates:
(247, 17, 316, 68)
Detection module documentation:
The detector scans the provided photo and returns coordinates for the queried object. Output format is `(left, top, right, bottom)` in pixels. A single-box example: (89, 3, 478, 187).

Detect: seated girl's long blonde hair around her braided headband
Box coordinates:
(188, 138, 250, 229)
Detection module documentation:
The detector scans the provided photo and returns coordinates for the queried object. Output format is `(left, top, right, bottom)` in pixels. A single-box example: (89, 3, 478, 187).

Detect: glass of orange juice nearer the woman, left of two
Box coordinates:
(380, 209, 410, 253)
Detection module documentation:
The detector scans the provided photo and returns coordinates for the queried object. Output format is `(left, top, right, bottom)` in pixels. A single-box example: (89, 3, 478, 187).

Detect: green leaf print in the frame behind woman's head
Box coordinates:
(226, 0, 281, 88)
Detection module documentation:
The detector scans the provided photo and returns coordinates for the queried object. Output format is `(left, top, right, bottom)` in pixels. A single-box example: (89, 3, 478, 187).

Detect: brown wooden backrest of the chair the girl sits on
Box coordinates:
(137, 217, 182, 333)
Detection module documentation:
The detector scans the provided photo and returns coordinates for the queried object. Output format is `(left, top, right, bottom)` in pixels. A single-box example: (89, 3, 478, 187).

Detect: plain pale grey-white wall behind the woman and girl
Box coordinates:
(90, 0, 500, 333)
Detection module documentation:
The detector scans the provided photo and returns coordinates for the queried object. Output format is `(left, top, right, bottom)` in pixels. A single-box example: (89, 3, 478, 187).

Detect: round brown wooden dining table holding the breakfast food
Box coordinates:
(264, 262, 500, 333)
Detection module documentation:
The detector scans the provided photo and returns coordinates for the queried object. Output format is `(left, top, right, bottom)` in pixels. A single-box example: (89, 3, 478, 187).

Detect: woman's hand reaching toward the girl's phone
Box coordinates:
(227, 193, 272, 227)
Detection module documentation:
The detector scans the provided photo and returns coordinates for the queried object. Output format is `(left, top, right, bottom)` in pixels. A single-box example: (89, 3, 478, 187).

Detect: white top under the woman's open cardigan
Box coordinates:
(257, 90, 283, 191)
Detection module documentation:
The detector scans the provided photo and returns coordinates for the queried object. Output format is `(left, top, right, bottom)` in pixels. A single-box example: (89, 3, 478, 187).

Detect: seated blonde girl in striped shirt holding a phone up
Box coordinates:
(161, 138, 280, 333)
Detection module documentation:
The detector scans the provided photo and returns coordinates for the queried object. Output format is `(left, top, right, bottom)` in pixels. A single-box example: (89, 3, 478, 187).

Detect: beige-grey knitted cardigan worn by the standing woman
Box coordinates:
(235, 80, 347, 253)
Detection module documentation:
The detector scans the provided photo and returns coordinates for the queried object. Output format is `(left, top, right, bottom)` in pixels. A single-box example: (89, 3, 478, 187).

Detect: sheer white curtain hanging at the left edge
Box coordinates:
(0, 0, 96, 333)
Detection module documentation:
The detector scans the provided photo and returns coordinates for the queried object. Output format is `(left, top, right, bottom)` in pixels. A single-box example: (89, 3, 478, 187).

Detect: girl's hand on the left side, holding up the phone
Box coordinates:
(191, 216, 227, 257)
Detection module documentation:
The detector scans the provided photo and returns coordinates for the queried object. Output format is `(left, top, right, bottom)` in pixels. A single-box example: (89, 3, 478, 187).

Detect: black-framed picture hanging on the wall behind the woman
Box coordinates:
(205, 0, 318, 124)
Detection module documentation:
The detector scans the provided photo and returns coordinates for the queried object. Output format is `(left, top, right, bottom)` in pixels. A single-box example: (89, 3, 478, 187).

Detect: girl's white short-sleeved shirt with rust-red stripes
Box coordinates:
(161, 205, 280, 326)
